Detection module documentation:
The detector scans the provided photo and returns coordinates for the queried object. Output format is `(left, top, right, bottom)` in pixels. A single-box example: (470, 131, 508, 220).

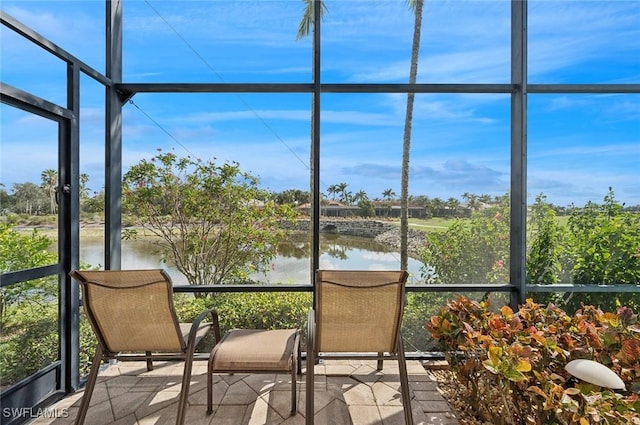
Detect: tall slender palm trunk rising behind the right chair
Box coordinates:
(400, 0, 424, 270)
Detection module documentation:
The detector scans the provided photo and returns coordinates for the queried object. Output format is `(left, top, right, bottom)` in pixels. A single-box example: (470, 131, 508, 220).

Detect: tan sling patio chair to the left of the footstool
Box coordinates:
(70, 269, 220, 425)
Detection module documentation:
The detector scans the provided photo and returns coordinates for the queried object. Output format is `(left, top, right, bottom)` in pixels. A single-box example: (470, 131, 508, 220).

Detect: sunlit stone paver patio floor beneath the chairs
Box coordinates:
(31, 360, 458, 425)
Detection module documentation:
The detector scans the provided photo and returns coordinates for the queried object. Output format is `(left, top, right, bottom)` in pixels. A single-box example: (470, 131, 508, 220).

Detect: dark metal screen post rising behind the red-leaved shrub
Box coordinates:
(509, 0, 527, 310)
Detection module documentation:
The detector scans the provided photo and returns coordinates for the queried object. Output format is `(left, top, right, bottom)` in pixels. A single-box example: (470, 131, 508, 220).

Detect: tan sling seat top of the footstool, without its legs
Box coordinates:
(211, 329, 298, 372)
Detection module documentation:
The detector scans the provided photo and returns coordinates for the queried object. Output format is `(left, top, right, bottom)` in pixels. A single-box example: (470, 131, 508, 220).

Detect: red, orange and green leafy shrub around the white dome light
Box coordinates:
(427, 297, 640, 424)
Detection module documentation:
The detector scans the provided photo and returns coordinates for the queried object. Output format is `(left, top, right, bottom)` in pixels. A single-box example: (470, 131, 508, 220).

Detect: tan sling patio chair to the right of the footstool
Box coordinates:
(306, 270, 413, 425)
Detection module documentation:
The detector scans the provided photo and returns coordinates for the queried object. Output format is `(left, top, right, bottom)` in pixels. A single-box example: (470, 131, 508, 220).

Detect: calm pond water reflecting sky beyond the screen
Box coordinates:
(80, 234, 422, 284)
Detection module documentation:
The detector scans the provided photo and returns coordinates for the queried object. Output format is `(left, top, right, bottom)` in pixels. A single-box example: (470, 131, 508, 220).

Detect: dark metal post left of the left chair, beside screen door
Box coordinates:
(57, 63, 80, 393)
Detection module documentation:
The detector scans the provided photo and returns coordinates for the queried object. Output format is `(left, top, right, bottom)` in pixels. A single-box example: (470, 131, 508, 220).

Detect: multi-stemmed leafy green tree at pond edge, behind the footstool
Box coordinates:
(123, 153, 293, 285)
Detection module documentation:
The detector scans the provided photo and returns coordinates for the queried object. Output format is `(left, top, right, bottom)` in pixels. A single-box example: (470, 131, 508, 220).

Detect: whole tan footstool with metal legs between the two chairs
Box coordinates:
(207, 329, 301, 415)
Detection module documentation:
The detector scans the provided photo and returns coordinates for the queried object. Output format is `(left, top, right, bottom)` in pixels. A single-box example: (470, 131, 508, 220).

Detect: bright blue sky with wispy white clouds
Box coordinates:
(0, 0, 640, 205)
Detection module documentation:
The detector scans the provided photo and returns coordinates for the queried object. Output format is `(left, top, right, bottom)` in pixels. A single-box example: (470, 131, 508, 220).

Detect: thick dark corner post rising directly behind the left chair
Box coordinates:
(104, 0, 123, 270)
